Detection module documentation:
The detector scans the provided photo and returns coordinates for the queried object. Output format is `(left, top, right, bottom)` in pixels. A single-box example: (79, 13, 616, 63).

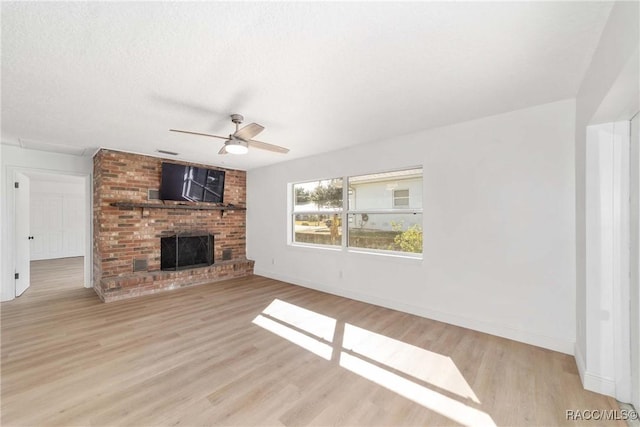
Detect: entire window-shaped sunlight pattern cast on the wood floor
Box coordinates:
(253, 299, 495, 426)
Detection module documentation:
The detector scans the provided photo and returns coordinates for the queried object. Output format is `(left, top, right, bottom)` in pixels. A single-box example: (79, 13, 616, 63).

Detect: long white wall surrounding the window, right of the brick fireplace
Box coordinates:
(247, 100, 575, 353)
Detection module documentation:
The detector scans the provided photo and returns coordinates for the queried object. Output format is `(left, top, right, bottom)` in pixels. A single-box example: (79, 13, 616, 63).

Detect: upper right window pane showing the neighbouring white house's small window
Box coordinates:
(349, 168, 422, 211)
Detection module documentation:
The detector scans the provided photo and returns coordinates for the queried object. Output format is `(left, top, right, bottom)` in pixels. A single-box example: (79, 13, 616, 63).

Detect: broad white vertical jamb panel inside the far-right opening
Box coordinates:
(579, 120, 632, 402)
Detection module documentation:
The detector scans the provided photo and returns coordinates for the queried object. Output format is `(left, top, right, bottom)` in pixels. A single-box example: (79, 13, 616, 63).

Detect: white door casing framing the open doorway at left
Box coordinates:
(2, 166, 93, 301)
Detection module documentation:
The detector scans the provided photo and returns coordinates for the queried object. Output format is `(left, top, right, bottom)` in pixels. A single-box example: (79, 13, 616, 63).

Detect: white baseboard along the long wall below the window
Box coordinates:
(254, 269, 575, 356)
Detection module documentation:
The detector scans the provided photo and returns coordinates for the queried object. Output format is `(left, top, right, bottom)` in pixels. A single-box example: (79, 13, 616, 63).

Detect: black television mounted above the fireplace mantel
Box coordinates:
(160, 162, 224, 203)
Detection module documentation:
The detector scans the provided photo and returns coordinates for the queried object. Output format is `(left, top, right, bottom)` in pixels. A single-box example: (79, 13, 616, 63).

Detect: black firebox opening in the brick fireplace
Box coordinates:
(160, 234, 213, 270)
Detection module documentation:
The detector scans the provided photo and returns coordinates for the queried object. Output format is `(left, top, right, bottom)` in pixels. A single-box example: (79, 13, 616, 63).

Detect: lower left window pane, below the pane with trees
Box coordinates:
(293, 213, 342, 246)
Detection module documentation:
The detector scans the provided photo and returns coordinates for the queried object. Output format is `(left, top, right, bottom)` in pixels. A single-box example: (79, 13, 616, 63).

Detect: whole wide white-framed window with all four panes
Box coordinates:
(291, 168, 422, 255)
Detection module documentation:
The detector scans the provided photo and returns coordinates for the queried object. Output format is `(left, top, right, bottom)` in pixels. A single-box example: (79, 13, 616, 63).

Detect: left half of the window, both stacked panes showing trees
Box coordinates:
(291, 178, 343, 246)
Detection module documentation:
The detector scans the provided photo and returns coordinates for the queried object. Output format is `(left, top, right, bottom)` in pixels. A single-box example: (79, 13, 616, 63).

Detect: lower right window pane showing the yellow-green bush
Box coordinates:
(348, 213, 422, 253)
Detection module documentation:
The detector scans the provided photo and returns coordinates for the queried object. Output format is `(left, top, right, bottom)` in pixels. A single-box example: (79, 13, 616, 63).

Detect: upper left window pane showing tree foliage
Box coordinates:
(293, 178, 342, 212)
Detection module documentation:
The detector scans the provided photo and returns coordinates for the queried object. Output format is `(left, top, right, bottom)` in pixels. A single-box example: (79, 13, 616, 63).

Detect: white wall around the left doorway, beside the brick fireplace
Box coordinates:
(0, 144, 93, 301)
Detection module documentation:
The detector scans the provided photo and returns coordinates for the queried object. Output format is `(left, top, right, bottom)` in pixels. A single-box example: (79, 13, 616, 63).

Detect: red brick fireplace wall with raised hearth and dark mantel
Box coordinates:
(93, 150, 253, 302)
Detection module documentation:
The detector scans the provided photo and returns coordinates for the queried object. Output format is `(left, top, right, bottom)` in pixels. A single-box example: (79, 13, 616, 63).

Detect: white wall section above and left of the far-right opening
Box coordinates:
(575, 2, 640, 398)
